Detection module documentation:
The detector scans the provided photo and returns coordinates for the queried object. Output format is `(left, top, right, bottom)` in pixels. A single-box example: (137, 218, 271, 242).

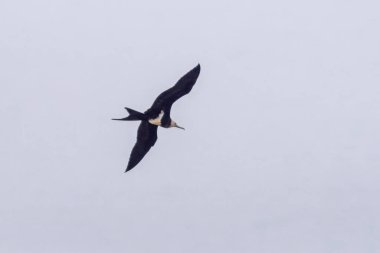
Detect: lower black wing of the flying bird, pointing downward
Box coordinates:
(125, 120, 157, 172)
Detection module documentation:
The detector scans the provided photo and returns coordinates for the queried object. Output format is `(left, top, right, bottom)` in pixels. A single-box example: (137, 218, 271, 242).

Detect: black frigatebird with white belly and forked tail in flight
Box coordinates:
(113, 64, 201, 172)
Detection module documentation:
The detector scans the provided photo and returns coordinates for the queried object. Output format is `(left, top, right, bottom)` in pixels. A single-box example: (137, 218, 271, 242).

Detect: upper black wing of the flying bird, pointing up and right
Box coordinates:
(149, 64, 201, 115)
